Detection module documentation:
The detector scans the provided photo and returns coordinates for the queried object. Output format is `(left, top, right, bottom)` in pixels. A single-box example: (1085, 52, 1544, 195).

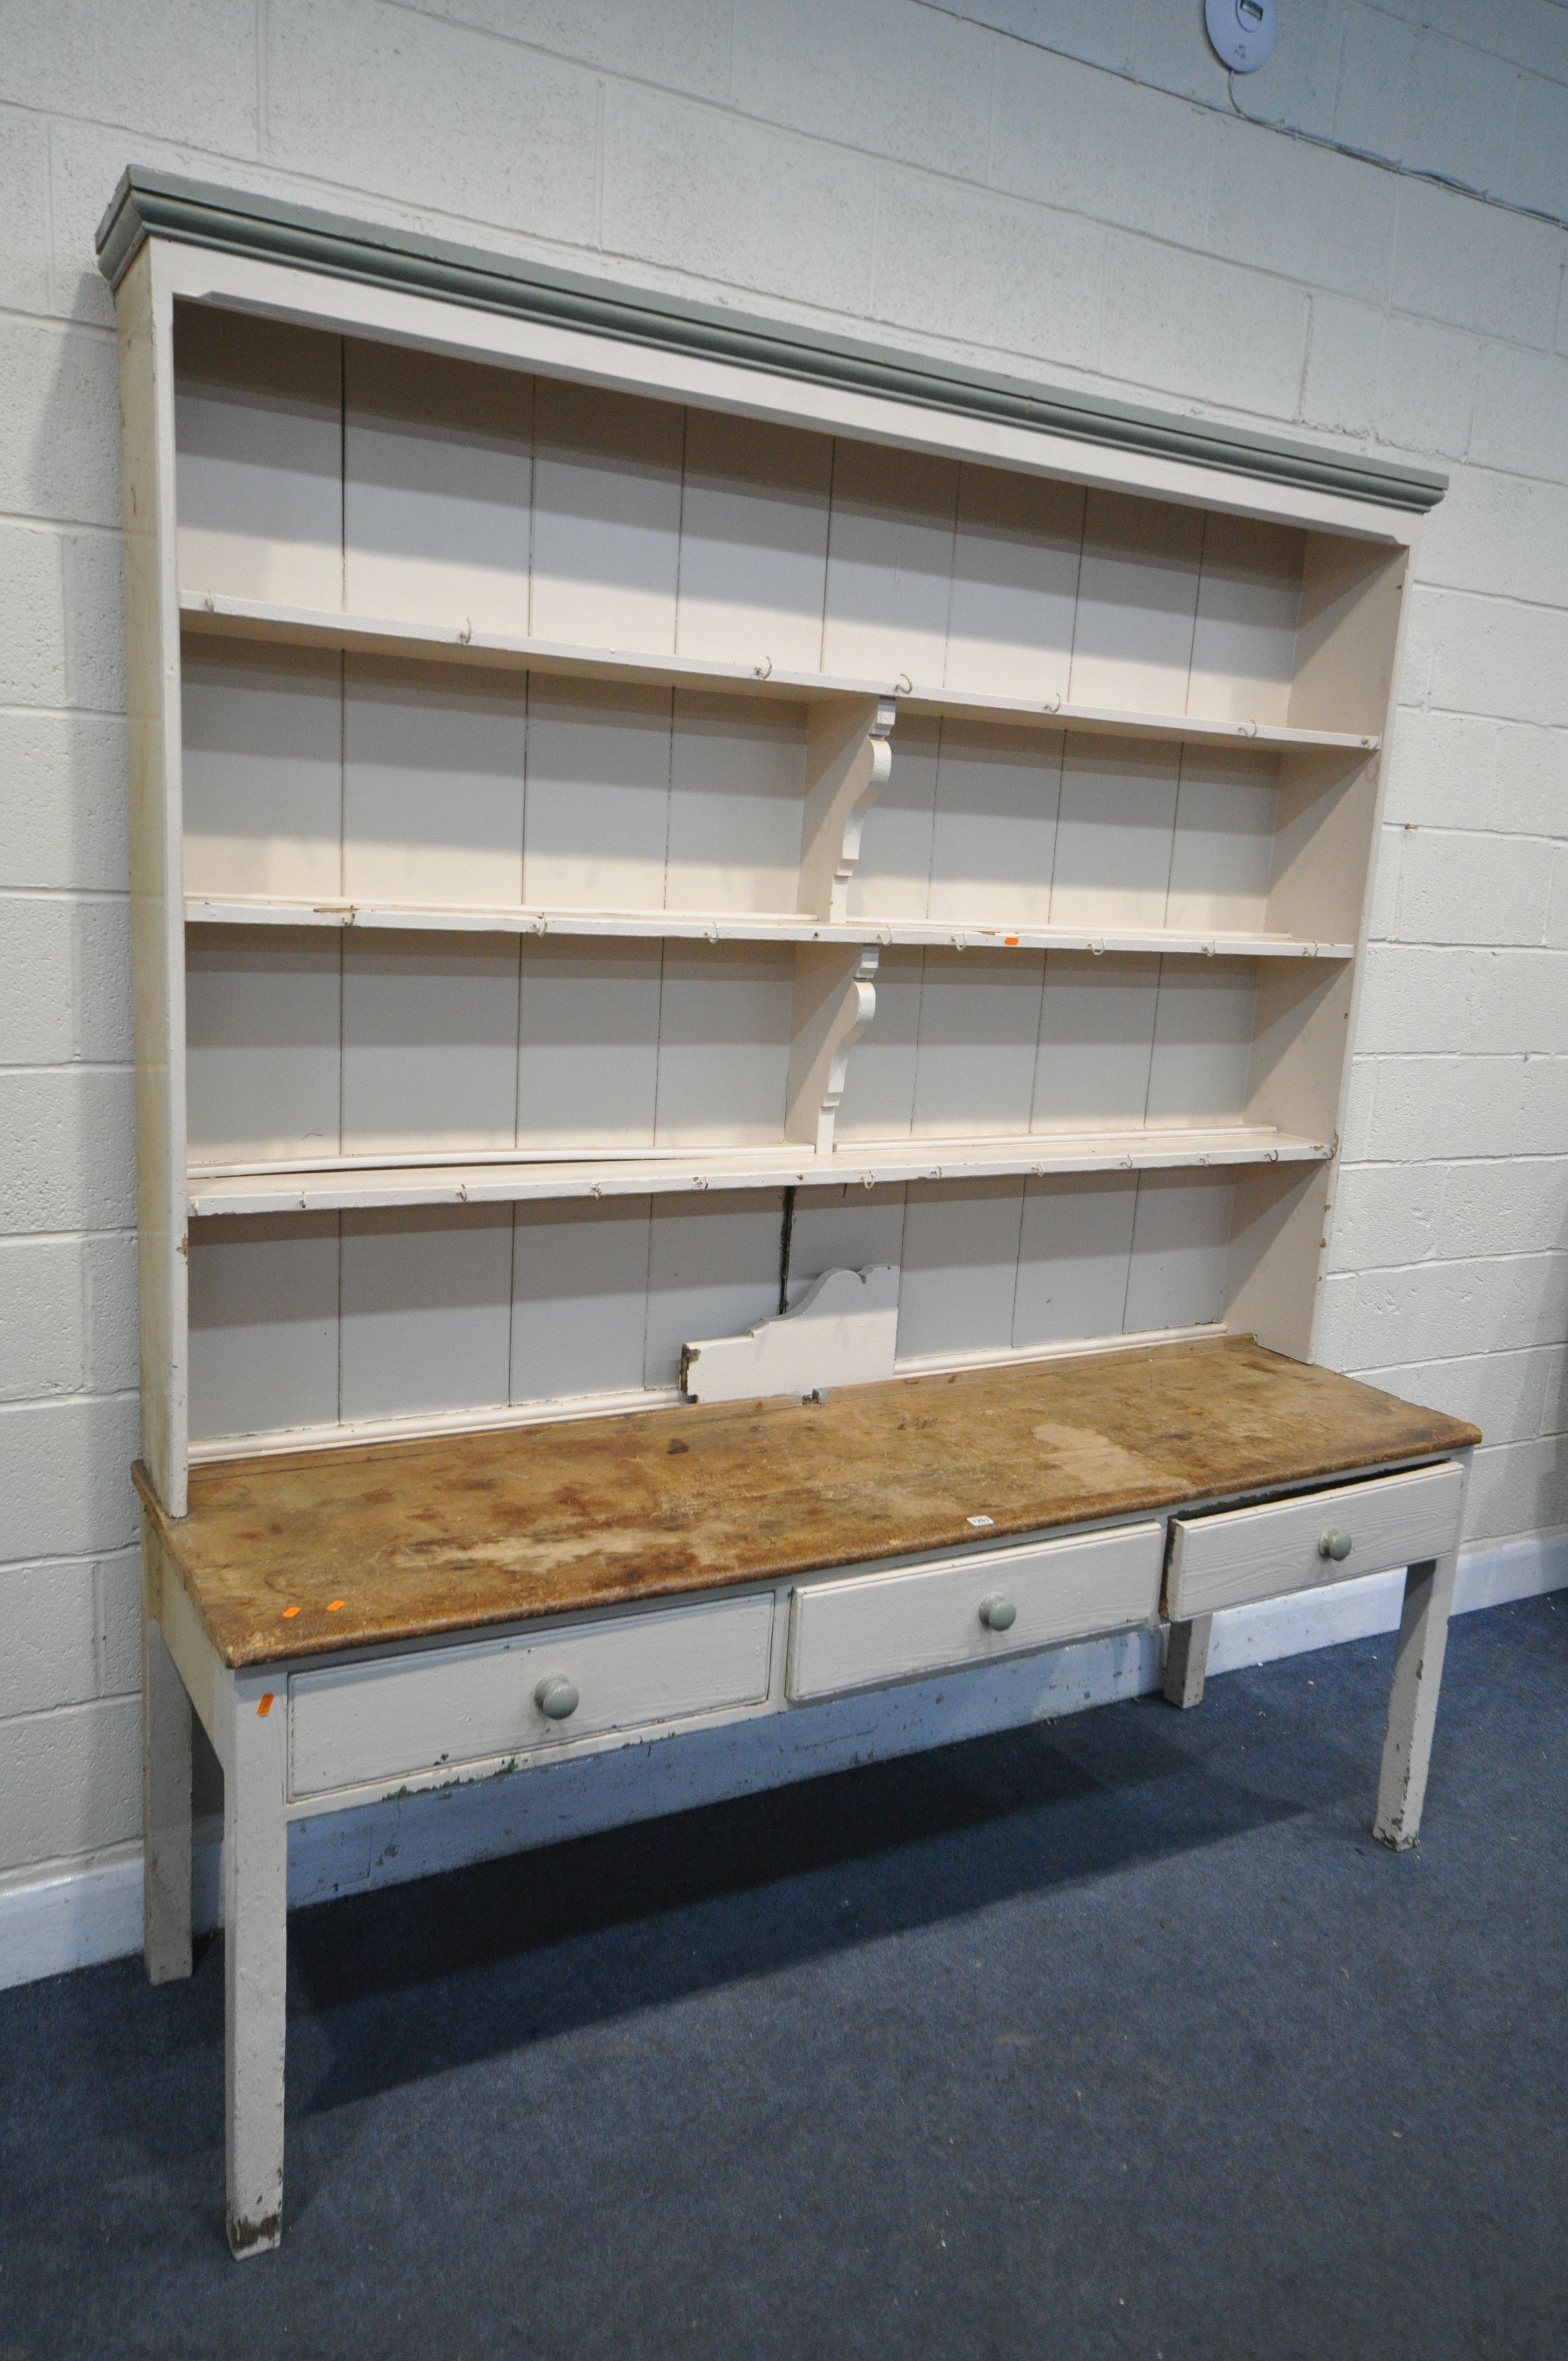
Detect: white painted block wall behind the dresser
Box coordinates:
(0, 0, 1568, 1877)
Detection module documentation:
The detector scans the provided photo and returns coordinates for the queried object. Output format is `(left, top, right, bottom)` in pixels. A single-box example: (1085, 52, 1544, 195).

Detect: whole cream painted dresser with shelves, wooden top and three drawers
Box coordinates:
(99, 170, 1478, 2255)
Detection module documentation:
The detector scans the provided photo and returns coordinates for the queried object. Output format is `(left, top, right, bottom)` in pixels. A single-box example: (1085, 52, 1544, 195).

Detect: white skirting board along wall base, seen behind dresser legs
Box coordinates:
(0, 1530, 1568, 1988)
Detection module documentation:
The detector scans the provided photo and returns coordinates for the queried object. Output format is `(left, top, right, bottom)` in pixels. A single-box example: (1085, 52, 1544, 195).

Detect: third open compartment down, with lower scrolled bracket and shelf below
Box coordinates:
(187, 906, 1351, 1214)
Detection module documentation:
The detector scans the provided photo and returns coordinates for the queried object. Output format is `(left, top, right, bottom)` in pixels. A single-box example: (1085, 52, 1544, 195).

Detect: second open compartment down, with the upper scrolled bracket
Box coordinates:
(182, 640, 1370, 961)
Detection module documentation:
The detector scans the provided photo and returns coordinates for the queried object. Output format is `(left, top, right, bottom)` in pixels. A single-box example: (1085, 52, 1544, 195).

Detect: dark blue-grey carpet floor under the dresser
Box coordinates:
(0, 1593, 1568, 2361)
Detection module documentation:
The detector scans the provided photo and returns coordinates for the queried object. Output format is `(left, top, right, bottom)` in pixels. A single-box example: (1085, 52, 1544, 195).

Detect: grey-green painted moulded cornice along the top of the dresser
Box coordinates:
(97, 165, 1447, 512)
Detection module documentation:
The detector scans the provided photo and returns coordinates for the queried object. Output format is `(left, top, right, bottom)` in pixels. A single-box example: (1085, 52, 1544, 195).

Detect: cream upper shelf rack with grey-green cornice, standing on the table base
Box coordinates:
(106, 175, 1440, 1516)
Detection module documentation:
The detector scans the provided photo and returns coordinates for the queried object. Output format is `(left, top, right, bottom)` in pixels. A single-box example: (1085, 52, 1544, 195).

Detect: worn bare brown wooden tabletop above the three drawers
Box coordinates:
(137, 1336, 1480, 1664)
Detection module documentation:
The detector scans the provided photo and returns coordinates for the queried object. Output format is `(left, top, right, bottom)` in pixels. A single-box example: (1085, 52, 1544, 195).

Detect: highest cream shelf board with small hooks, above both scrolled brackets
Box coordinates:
(179, 592, 1379, 753)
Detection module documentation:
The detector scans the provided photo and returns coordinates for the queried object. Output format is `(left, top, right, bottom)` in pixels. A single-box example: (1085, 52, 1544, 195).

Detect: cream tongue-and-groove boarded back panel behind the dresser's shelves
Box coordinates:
(159, 307, 1393, 1454)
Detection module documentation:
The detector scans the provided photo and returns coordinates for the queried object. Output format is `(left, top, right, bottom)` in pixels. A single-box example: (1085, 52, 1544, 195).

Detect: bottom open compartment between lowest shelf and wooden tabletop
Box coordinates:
(177, 1162, 1322, 1457)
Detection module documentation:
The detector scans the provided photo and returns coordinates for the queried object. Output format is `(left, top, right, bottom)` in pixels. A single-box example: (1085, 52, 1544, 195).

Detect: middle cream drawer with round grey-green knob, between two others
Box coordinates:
(786, 1525, 1164, 1700)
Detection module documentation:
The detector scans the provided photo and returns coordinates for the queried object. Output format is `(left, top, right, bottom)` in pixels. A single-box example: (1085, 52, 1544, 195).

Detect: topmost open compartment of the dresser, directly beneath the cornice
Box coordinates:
(177, 307, 1389, 753)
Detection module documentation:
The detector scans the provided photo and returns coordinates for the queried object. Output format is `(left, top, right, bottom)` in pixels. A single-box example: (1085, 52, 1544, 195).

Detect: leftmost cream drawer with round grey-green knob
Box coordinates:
(288, 1591, 772, 1797)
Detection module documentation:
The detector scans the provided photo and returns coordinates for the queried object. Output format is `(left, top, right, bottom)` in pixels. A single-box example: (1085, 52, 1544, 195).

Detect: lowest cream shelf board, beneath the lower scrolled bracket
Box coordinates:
(189, 1124, 1334, 1216)
